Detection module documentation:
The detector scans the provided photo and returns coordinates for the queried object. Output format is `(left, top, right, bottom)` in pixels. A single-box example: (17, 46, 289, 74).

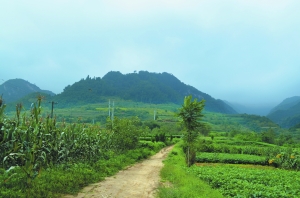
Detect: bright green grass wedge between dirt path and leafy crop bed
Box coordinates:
(158, 143, 223, 198)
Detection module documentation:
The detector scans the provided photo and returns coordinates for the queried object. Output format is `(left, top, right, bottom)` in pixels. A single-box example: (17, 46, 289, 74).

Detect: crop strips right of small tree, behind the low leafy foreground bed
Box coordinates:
(197, 139, 300, 170)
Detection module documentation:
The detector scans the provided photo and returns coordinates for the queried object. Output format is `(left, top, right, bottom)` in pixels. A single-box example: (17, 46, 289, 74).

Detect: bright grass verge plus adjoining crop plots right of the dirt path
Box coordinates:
(160, 138, 300, 198)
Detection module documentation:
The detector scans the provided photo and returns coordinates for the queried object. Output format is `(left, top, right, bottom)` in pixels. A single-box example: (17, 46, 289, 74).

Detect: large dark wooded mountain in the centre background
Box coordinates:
(54, 71, 236, 114)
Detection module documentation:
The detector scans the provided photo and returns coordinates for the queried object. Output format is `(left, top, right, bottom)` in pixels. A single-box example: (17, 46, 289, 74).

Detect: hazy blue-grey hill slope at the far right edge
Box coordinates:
(267, 96, 300, 128)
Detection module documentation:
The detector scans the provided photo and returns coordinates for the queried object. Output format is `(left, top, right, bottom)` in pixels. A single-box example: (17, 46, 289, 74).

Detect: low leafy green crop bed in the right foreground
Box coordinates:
(189, 165, 300, 198)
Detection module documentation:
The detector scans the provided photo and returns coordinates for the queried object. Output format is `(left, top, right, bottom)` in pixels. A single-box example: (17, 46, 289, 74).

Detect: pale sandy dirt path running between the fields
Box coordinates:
(65, 146, 173, 198)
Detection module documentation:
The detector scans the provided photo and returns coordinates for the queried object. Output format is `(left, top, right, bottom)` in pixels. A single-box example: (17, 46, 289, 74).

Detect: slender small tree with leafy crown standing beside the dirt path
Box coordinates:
(177, 95, 205, 167)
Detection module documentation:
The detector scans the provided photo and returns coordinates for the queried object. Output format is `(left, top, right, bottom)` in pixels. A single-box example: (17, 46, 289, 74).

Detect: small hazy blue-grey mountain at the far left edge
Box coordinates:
(0, 79, 55, 103)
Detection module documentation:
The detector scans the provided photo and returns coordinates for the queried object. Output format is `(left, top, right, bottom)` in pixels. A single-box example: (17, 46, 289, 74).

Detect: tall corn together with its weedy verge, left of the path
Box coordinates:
(0, 97, 164, 197)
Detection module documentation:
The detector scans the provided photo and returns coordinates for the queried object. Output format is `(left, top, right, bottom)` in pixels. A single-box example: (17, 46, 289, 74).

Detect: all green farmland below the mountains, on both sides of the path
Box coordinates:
(0, 95, 300, 197)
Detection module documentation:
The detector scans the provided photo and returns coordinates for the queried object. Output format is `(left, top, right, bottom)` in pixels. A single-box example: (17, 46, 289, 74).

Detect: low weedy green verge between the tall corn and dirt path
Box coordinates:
(0, 142, 165, 198)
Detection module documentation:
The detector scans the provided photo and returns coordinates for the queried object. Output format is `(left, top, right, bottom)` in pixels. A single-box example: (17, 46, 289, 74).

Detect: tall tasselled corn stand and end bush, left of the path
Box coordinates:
(0, 97, 143, 188)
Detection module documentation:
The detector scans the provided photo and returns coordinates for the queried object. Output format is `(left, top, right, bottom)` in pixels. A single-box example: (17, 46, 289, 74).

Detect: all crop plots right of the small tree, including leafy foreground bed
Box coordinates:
(188, 138, 300, 198)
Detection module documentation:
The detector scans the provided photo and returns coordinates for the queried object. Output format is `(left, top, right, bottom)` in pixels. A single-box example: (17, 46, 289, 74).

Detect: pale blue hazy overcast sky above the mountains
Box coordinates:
(0, 0, 300, 113)
